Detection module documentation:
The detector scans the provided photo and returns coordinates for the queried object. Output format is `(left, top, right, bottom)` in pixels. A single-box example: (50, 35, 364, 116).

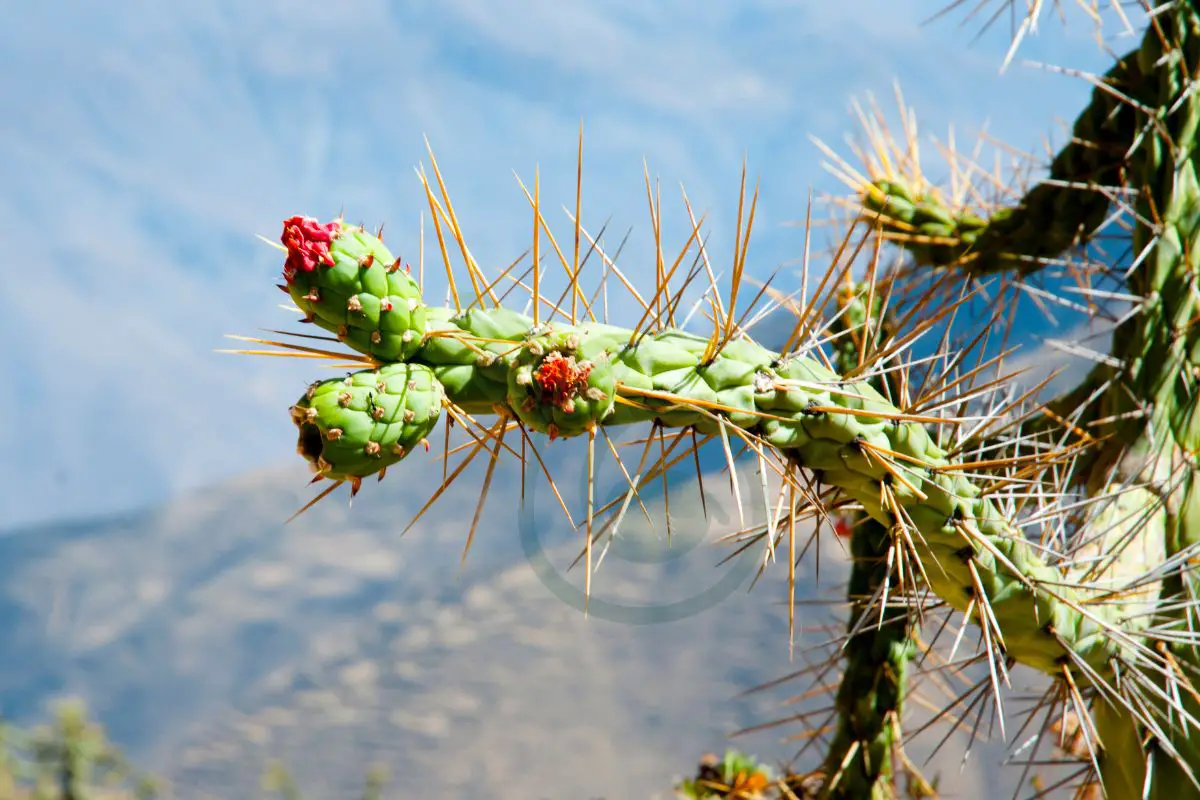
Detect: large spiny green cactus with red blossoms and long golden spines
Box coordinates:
(231, 2, 1200, 800)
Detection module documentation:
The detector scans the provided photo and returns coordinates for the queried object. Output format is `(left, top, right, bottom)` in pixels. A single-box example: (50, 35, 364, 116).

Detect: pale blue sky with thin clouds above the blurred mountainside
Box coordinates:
(0, 0, 1128, 529)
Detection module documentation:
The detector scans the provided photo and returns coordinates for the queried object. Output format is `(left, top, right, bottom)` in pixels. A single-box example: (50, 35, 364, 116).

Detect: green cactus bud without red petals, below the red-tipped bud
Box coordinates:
(292, 363, 444, 480)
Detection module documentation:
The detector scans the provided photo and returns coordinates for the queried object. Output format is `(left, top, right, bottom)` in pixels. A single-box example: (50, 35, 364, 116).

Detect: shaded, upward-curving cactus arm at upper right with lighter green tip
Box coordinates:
(862, 53, 1142, 275)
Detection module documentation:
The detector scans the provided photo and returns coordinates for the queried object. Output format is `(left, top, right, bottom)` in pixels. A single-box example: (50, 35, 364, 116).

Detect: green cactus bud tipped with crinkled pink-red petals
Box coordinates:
(282, 217, 426, 361)
